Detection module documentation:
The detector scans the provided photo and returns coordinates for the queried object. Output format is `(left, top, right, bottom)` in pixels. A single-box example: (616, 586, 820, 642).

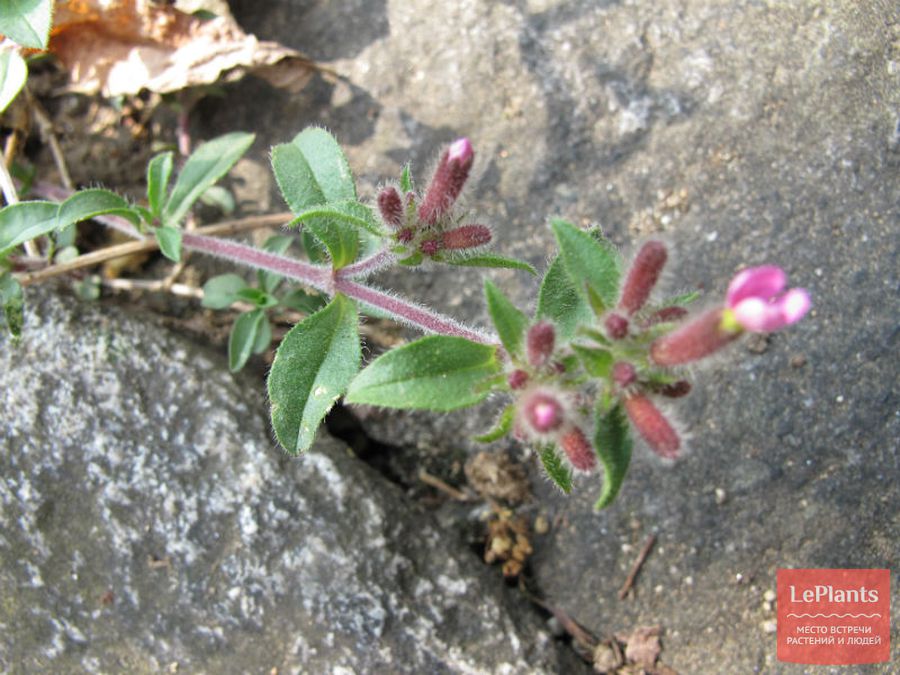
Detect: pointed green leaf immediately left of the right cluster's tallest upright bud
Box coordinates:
(550, 220, 622, 307)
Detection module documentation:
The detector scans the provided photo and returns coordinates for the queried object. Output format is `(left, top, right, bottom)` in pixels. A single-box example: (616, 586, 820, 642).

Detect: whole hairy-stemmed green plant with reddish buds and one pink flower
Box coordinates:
(0, 128, 810, 508)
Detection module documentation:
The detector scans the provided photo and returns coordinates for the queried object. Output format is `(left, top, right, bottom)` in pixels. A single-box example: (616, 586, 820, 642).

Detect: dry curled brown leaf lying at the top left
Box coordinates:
(50, 0, 317, 96)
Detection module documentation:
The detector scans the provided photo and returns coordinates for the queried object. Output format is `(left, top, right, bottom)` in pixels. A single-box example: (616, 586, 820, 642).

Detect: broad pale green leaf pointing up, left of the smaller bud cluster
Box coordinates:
(272, 127, 356, 213)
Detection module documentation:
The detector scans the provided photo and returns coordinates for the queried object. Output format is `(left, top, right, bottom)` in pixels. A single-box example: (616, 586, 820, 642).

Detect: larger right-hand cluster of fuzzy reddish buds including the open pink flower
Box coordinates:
(507, 241, 810, 472)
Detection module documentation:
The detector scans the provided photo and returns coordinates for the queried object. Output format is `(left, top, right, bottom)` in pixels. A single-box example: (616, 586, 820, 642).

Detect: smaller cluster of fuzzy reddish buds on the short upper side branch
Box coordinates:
(377, 138, 491, 258)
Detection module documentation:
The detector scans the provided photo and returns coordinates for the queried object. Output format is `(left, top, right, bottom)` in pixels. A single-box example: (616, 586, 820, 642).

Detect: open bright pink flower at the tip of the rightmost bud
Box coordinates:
(725, 265, 811, 333)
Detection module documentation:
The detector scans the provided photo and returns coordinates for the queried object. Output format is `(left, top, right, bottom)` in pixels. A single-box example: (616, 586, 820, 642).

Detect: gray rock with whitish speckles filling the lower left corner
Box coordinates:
(0, 291, 567, 673)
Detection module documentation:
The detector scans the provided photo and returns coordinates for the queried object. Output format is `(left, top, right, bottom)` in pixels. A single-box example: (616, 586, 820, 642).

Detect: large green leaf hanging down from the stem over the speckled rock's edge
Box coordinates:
(268, 295, 362, 454)
